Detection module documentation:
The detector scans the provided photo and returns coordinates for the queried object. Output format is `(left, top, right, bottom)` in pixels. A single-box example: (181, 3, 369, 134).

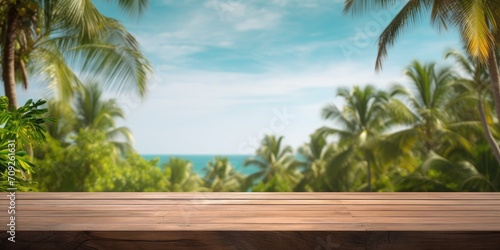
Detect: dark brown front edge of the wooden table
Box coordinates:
(0, 231, 500, 250)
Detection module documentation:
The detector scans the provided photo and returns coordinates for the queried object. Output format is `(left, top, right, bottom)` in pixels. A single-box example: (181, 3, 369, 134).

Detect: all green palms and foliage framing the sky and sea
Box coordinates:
(0, 0, 500, 192)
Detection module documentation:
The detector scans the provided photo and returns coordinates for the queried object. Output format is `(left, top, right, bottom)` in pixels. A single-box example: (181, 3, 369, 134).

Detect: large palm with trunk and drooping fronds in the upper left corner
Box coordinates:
(0, 0, 151, 106)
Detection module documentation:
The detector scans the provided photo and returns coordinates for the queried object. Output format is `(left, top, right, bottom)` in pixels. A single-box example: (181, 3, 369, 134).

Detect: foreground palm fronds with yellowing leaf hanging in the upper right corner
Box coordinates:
(344, 0, 500, 131)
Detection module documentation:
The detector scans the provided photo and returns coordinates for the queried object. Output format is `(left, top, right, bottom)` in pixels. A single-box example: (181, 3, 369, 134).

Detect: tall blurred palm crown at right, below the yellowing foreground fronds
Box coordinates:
(387, 61, 471, 157)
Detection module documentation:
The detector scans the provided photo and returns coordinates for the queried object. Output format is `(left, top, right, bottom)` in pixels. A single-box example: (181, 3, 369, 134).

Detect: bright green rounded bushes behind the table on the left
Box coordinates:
(33, 129, 169, 192)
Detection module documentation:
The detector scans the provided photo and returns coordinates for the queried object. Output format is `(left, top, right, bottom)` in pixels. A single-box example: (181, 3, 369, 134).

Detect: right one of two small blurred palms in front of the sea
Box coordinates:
(203, 157, 246, 192)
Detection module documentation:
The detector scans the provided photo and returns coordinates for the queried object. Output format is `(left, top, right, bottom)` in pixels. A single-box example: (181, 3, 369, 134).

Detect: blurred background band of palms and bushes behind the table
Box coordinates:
(22, 51, 500, 192)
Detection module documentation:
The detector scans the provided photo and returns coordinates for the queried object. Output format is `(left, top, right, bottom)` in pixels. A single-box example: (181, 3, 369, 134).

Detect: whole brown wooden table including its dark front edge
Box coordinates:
(0, 193, 500, 249)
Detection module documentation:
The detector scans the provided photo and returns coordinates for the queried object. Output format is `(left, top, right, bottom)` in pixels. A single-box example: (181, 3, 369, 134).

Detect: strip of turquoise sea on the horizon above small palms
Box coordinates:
(142, 154, 257, 177)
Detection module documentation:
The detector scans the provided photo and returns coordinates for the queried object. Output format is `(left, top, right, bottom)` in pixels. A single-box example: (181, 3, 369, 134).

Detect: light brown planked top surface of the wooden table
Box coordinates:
(0, 193, 500, 231)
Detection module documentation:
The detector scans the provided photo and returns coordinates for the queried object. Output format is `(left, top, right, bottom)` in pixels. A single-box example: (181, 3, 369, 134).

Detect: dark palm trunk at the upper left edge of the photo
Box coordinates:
(2, 4, 18, 108)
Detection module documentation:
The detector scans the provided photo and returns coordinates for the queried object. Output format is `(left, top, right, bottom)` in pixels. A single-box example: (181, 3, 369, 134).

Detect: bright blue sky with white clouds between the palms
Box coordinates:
(19, 0, 460, 154)
